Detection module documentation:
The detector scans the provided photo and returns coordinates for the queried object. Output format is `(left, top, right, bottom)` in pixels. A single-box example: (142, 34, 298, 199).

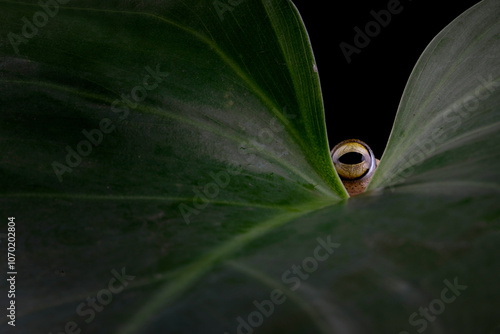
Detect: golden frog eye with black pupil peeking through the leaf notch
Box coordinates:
(331, 139, 376, 181)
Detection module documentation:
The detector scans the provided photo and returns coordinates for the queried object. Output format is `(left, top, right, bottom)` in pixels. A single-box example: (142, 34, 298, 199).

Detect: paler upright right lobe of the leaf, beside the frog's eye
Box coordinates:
(370, 1, 500, 192)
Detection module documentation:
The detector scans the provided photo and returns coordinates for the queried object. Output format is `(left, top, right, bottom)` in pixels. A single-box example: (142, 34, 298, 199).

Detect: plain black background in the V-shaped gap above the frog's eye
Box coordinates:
(292, 0, 479, 158)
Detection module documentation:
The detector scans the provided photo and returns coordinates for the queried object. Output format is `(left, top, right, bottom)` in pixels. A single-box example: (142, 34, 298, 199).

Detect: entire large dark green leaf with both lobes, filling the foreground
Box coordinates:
(0, 0, 500, 333)
